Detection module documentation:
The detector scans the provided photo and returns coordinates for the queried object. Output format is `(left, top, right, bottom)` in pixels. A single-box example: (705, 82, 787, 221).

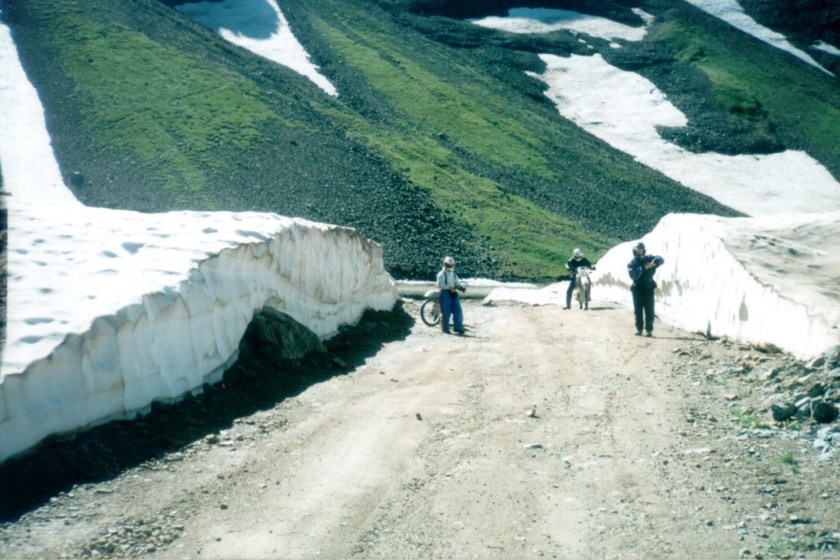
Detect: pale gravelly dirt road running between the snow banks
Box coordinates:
(0, 300, 840, 559)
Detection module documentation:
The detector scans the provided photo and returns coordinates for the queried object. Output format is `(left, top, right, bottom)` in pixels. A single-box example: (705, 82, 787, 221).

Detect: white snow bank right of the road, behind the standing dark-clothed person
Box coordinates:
(593, 212, 840, 358)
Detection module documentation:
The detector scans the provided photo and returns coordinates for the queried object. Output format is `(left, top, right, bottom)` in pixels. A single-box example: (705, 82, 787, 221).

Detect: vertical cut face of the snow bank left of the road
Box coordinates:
(0, 221, 398, 461)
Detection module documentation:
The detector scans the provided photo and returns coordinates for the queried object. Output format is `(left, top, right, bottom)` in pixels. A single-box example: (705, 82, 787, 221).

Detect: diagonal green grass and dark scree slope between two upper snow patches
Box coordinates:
(285, 0, 712, 277)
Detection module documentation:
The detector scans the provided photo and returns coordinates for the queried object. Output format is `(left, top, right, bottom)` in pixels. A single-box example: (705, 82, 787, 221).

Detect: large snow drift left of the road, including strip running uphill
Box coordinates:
(0, 19, 397, 461)
